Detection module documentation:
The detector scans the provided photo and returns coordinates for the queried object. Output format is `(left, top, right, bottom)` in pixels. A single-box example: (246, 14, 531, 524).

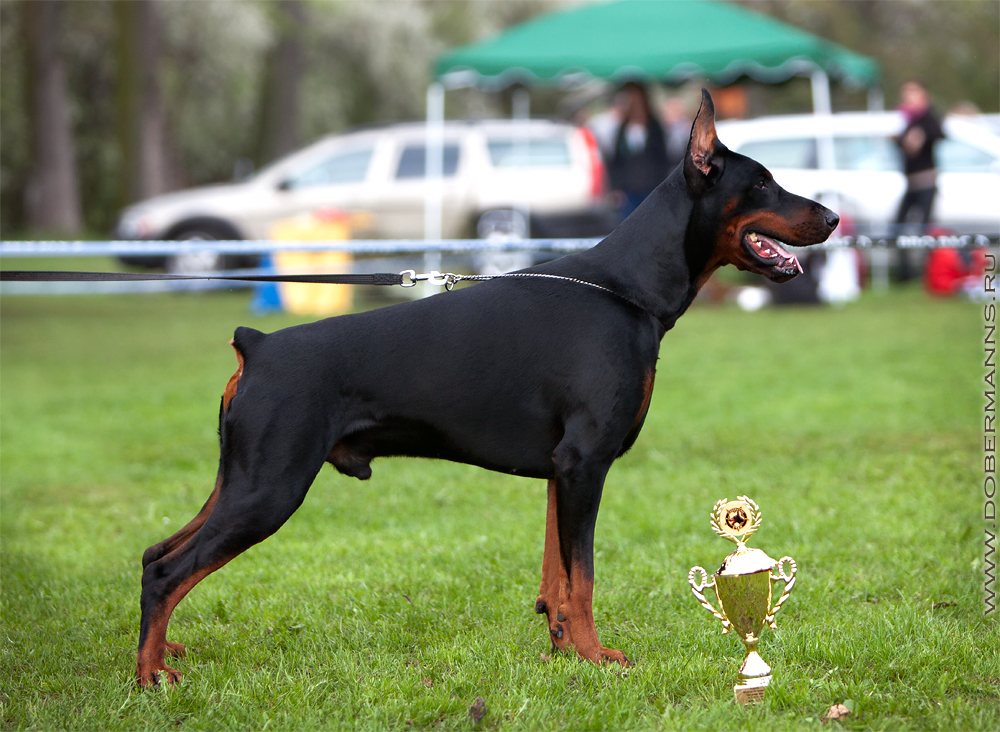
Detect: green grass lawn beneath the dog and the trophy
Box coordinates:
(0, 290, 1000, 732)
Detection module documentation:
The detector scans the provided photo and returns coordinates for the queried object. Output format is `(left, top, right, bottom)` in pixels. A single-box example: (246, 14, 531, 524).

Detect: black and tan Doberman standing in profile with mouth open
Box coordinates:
(136, 92, 838, 685)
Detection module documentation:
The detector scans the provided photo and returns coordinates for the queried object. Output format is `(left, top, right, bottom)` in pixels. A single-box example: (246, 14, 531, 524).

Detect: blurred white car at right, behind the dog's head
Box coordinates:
(717, 112, 1000, 233)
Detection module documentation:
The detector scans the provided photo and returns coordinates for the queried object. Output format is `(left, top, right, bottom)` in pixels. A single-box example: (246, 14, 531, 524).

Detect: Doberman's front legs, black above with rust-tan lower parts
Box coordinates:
(535, 438, 629, 666)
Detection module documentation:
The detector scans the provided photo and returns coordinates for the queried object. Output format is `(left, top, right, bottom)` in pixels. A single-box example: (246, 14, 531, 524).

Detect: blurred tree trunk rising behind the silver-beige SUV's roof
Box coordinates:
(257, 0, 306, 165)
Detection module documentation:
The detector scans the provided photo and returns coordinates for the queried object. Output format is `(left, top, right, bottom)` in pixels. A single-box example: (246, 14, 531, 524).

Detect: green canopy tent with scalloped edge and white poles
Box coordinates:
(424, 0, 881, 239)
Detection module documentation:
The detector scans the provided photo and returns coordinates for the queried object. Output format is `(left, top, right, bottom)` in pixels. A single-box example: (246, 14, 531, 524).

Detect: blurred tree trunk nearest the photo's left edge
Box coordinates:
(23, 0, 83, 233)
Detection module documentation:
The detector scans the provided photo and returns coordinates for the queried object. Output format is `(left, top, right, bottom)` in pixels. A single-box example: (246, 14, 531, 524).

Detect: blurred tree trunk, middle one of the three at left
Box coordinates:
(114, 0, 173, 205)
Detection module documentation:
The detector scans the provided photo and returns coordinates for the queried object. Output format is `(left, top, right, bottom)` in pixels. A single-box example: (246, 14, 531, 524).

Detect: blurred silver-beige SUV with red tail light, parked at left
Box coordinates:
(115, 120, 613, 270)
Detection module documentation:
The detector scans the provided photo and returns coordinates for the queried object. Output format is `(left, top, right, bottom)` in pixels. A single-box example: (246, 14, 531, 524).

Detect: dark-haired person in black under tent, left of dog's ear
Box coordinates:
(608, 81, 669, 219)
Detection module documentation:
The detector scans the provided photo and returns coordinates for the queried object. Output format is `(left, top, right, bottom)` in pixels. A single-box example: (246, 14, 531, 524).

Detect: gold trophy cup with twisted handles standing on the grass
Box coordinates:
(688, 496, 795, 704)
